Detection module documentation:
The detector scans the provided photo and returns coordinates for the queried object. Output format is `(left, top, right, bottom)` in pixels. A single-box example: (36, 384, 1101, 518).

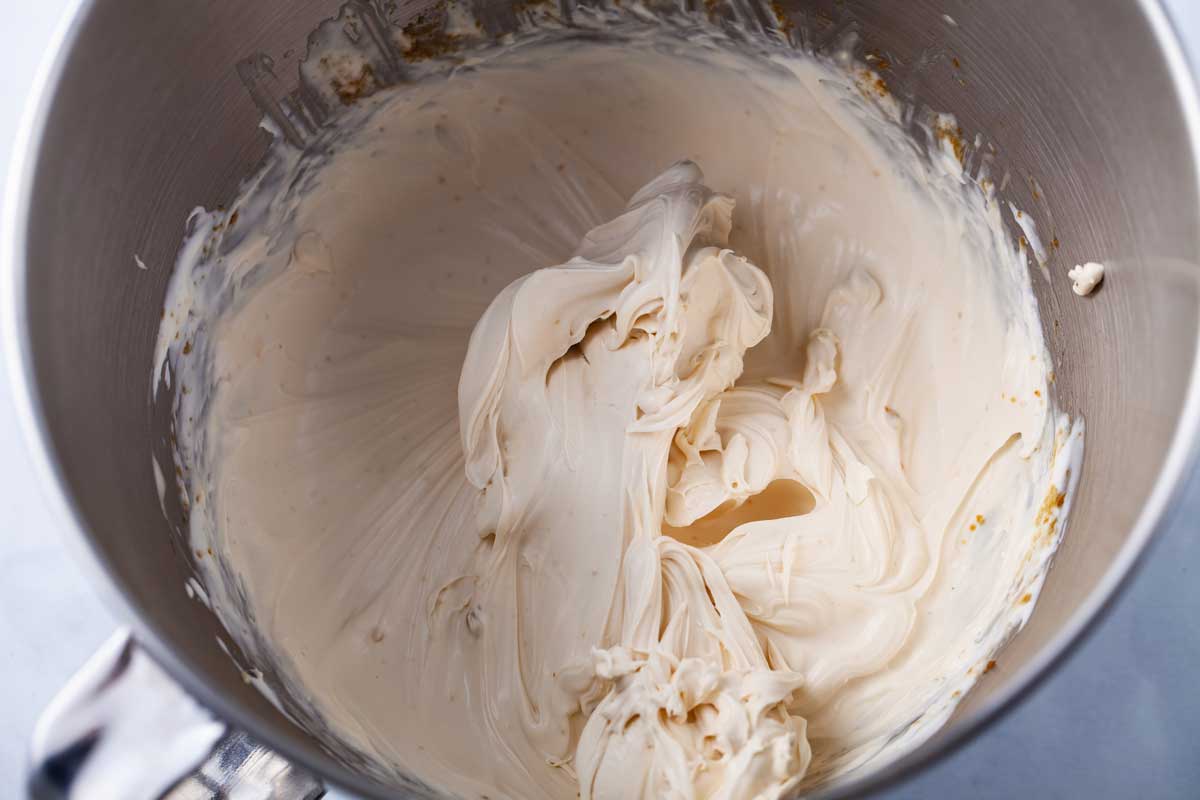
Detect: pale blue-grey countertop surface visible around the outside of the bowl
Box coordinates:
(0, 0, 1200, 800)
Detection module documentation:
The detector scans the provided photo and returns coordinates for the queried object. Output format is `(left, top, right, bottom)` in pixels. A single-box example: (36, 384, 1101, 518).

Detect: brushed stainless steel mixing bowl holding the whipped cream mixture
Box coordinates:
(4, 0, 1200, 796)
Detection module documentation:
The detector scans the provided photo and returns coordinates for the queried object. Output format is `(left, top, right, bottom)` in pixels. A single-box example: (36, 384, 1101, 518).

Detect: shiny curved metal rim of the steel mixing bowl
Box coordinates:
(0, 0, 1200, 800)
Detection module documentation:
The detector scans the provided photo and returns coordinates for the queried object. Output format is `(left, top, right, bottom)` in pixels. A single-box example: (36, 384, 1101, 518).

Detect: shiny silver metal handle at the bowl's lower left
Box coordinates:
(26, 630, 325, 800)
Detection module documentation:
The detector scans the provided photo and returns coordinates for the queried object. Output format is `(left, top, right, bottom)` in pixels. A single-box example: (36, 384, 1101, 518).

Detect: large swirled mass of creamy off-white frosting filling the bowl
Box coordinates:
(156, 12, 1082, 799)
